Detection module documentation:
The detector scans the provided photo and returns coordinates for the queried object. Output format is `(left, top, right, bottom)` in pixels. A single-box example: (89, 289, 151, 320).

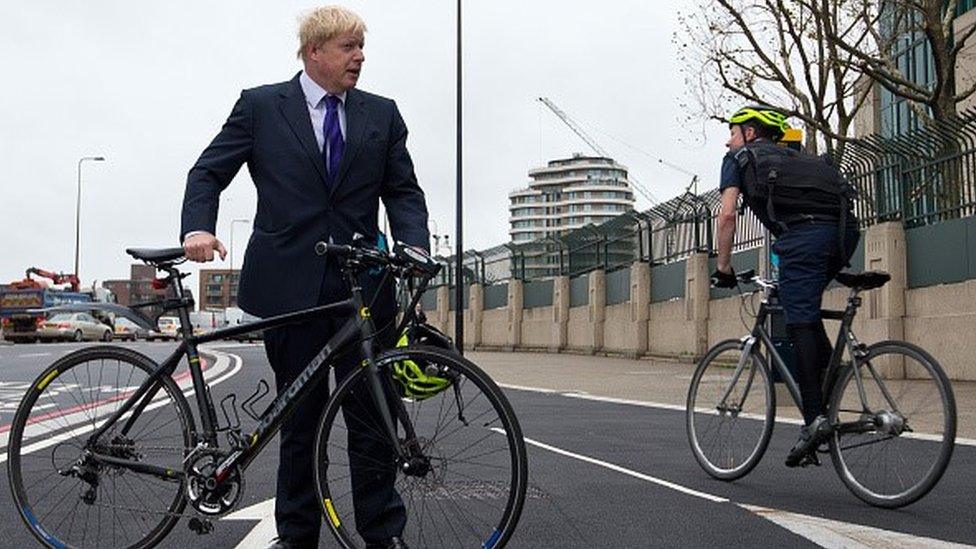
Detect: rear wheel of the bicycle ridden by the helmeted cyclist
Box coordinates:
(829, 341, 956, 508)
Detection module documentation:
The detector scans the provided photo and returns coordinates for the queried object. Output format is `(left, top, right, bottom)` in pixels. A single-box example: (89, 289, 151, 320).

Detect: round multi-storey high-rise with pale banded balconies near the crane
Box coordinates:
(508, 154, 634, 244)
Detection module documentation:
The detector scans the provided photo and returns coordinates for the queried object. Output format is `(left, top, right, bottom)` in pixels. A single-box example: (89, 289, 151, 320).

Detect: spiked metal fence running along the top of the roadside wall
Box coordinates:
(436, 109, 976, 285)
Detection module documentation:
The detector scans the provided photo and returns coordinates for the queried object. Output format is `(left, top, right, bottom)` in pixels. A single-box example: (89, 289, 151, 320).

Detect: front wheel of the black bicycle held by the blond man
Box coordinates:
(315, 346, 527, 547)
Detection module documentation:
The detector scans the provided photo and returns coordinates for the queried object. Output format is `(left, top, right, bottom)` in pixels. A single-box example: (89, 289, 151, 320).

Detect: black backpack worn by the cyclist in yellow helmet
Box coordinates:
(735, 142, 856, 255)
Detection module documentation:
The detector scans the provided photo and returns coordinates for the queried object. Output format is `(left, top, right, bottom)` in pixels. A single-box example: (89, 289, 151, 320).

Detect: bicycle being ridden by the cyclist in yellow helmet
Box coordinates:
(686, 271, 956, 508)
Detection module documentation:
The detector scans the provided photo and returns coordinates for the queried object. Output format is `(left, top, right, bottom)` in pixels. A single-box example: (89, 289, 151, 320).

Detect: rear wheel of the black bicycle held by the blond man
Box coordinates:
(7, 345, 194, 548)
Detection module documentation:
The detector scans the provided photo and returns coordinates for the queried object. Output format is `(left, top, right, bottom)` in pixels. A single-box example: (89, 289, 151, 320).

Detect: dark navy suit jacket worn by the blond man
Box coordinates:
(180, 75, 430, 317)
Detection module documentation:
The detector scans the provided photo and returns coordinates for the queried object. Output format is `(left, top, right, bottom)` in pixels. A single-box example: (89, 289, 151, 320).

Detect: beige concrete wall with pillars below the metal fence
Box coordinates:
(438, 223, 976, 380)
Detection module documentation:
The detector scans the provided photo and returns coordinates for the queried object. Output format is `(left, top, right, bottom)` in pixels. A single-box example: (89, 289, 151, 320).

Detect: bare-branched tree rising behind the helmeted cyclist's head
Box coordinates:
(674, 0, 871, 154)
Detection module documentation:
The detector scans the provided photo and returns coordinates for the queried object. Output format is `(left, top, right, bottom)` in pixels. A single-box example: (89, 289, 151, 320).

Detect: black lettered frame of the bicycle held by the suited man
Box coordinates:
(87, 268, 427, 484)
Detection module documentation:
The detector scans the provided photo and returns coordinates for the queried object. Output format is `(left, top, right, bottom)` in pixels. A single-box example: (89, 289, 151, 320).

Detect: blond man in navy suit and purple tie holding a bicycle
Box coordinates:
(181, 6, 429, 547)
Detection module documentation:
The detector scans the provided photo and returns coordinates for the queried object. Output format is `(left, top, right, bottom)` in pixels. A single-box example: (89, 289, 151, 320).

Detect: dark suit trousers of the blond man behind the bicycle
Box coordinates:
(264, 272, 406, 547)
